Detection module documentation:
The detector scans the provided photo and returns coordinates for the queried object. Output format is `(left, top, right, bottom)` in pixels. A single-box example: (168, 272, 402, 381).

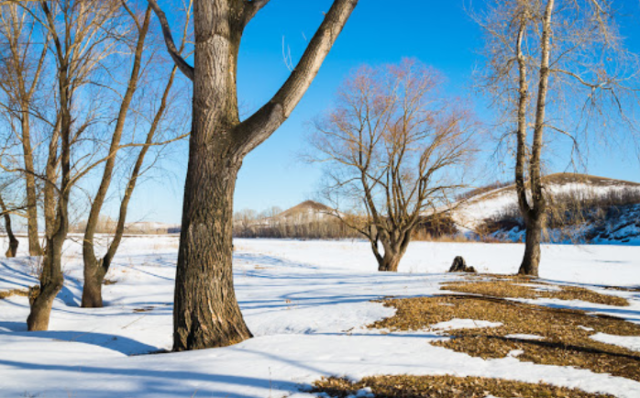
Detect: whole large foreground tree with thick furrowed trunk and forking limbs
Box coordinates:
(149, 0, 358, 351)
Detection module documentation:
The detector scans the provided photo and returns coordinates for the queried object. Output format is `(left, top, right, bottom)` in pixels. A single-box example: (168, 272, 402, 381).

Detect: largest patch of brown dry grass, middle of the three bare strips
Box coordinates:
(370, 295, 640, 381)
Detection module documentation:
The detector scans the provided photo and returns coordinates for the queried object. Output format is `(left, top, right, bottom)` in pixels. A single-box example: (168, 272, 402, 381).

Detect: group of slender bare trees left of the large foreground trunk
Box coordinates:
(0, 0, 190, 330)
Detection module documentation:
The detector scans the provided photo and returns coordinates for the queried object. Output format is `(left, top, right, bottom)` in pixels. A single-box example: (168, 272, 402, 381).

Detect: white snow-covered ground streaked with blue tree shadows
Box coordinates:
(0, 237, 640, 398)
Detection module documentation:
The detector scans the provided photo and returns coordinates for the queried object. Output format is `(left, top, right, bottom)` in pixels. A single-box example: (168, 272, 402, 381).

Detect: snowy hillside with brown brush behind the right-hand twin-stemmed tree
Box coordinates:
(451, 173, 640, 244)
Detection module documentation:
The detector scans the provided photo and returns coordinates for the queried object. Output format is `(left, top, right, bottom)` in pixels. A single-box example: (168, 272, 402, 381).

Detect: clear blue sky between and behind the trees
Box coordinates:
(130, 0, 640, 223)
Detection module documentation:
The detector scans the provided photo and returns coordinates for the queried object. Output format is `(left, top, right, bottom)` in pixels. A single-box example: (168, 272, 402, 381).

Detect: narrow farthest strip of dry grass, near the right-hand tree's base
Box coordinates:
(440, 277, 629, 307)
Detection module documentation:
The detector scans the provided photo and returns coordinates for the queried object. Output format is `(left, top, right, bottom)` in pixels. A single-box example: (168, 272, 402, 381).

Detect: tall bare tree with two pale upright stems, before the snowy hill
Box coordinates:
(476, 0, 637, 276)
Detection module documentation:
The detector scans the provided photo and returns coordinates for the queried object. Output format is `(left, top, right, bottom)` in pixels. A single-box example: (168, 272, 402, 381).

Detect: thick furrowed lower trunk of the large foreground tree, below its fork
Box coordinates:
(173, 154, 252, 351)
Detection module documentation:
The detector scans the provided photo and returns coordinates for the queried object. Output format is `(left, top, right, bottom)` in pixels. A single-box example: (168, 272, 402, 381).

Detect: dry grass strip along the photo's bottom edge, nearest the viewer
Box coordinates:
(313, 376, 613, 398)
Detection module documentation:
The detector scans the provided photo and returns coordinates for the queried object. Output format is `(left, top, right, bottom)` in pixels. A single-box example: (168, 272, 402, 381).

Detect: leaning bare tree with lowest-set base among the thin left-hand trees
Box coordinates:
(27, 0, 122, 330)
